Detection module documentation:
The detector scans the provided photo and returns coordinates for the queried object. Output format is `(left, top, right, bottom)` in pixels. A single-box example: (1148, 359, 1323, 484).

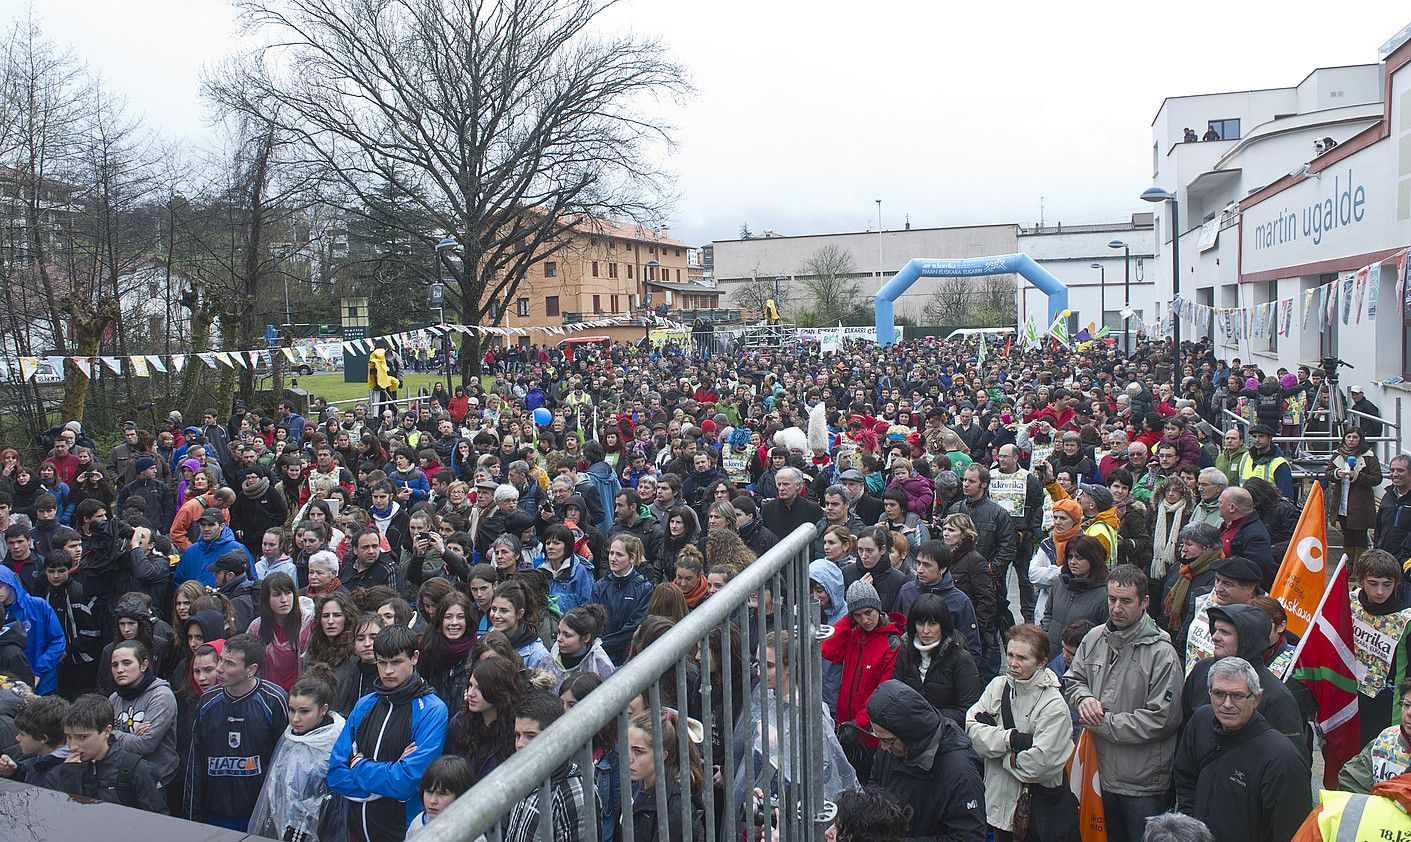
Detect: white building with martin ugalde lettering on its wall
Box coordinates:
(1149, 21, 1411, 447)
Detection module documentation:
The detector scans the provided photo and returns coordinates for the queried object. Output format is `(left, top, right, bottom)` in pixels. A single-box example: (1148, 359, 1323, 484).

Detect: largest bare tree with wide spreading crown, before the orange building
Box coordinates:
(207, 0, 687, 381)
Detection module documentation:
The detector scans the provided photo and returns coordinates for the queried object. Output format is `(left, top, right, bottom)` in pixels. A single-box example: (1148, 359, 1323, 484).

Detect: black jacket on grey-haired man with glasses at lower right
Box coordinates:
(1174, 705, 1311, 842)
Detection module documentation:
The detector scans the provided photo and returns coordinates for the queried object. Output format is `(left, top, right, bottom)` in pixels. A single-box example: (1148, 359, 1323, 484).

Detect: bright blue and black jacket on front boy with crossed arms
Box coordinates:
(329, 673, 449, 838)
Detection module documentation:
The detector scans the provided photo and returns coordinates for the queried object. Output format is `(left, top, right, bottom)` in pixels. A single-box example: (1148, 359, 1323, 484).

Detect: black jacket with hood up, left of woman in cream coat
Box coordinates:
(868, 678, 987, 842)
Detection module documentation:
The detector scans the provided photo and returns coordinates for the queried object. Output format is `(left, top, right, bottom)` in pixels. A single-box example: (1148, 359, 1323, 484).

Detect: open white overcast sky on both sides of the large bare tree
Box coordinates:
(22, 0, 1411, 243)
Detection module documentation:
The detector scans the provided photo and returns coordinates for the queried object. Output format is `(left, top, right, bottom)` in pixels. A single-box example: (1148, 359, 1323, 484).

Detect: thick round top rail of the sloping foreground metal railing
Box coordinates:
(416, 523, 816, 842)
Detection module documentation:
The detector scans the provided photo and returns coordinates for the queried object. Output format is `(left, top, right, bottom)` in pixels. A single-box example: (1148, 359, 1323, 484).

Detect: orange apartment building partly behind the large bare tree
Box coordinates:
(499, 220, 720, 344)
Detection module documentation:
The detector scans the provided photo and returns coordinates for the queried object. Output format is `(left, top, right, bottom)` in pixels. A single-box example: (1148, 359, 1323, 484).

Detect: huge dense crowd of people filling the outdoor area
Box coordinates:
(0, 330, 1411, 842)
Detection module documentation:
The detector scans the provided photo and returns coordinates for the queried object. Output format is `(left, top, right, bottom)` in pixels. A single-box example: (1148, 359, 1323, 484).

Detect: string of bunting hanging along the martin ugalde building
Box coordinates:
(1170, 248, 1411, 341)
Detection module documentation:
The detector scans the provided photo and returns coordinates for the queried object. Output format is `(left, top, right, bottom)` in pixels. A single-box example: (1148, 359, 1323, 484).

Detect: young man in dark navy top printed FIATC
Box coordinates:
(183, 635, 289, 831)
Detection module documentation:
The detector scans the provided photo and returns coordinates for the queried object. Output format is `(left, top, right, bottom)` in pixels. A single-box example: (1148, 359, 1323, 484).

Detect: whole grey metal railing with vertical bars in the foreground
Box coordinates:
(416, 525, 832, 842)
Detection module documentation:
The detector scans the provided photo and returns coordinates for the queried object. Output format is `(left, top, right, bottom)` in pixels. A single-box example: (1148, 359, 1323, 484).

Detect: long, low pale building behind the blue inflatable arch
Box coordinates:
(707, 213, 1156, 330)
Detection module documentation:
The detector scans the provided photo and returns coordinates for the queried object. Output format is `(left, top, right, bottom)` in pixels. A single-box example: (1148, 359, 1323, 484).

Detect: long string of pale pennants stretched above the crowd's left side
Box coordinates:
(5, 315, 677, 379)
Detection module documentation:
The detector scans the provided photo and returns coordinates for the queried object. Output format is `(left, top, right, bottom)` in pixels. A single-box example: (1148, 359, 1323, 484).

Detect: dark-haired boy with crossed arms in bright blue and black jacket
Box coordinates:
(329, 626, 447, 842)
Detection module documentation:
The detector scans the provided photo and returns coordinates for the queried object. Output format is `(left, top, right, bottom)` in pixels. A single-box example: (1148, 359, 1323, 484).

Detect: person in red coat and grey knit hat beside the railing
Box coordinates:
(821, 575, 906, 780)
